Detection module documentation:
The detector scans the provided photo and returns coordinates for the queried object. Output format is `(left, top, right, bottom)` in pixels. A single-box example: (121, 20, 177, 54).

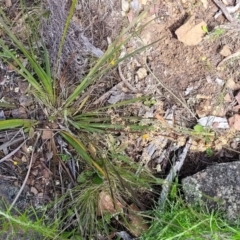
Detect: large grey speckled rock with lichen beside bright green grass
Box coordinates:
(182, 161, 240, 220)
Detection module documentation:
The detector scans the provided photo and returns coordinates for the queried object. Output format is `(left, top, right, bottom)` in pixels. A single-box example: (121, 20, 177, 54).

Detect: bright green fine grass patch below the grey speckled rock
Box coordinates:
(141, 197, 240, 240)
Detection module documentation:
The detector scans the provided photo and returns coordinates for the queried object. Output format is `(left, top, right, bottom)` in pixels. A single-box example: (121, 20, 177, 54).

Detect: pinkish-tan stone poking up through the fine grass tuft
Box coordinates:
(97, 191, 123, 216)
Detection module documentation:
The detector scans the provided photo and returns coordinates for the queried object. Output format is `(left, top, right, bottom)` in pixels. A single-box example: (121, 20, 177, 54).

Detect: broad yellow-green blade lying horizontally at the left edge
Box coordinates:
(0, 119, 37, 130)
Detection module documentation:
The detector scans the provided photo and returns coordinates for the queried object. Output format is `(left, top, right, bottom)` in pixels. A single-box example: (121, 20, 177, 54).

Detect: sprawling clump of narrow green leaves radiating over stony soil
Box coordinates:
(0, 0, 159, 237)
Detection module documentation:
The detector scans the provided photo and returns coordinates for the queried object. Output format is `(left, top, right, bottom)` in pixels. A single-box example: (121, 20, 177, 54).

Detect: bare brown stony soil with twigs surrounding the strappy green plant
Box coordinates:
(0, 0, 240, 238)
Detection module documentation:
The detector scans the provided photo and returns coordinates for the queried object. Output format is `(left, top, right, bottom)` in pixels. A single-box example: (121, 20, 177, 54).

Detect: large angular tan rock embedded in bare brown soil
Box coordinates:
(175, 17, 207, 46)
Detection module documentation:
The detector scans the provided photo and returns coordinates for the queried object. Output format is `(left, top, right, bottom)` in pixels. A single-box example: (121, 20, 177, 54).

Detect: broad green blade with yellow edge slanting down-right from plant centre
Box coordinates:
(61, 131, 107, 178)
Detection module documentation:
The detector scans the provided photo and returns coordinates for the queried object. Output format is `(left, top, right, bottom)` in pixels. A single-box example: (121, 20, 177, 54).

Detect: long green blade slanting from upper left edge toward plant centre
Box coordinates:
(0, 17, 54, 103)
